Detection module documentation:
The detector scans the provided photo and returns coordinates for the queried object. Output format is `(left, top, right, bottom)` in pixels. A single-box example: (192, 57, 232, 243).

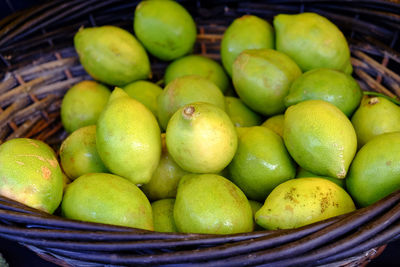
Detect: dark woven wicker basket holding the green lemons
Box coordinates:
(0, 0, 400, 266)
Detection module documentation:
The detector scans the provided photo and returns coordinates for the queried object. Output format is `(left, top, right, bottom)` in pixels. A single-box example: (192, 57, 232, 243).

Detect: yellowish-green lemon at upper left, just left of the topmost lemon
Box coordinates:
(74, 26, 150, 86)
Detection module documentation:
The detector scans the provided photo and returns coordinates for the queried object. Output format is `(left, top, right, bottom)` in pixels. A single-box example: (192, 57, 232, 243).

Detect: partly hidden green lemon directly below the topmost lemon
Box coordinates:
(164, 55, 230, 93)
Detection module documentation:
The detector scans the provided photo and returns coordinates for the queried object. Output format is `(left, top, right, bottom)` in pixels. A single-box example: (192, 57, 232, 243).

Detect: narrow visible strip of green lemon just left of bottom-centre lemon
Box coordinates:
(151, 198, 178, 232)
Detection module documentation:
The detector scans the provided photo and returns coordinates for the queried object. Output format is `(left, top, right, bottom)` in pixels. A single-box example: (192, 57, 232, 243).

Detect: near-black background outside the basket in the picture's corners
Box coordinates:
(0, 0, 400, 267)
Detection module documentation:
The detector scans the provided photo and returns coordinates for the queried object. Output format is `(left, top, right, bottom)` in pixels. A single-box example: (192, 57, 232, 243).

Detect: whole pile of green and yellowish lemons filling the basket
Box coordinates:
(0, 0, 400, 234)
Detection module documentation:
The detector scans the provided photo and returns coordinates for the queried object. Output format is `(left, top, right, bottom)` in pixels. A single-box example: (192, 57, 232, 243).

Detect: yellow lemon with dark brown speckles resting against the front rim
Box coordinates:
(256, 178, 355, 230)
